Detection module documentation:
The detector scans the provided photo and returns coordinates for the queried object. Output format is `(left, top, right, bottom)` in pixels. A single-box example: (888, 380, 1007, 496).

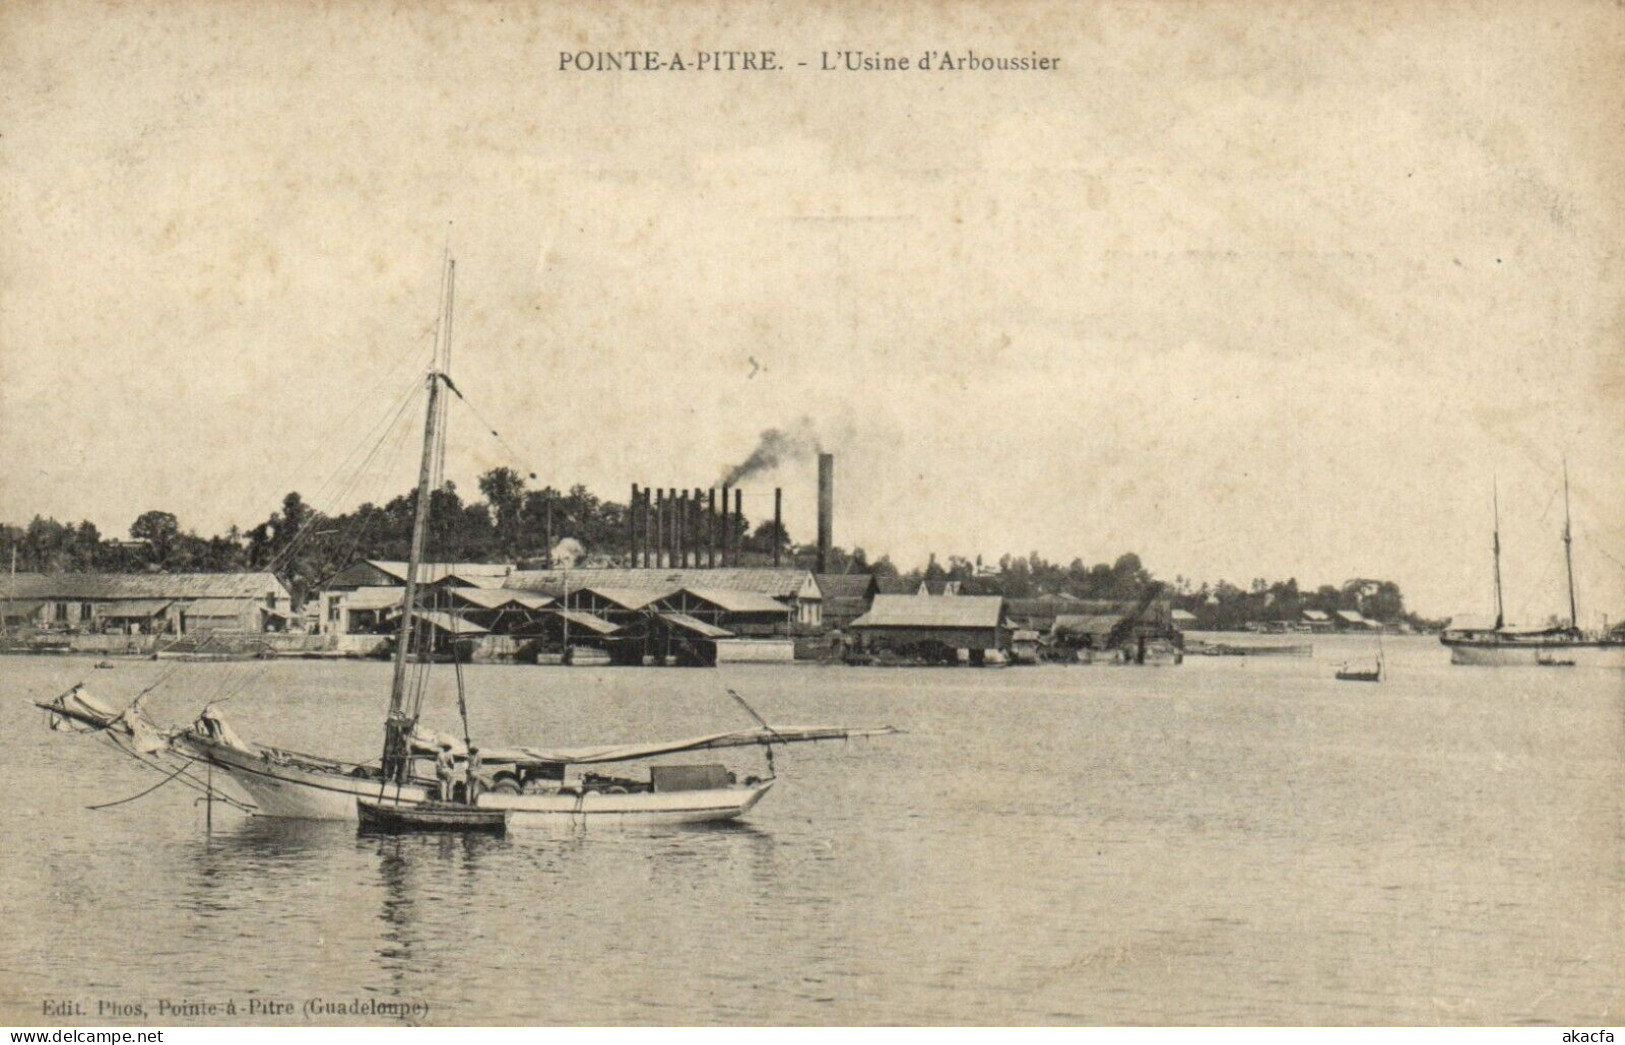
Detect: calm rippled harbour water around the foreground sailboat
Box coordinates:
(0, 639, 1625, 1025)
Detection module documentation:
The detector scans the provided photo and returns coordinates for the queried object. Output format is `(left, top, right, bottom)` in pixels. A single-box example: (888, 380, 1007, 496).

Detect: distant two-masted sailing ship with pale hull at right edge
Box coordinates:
(1438, 463, 1625, 668)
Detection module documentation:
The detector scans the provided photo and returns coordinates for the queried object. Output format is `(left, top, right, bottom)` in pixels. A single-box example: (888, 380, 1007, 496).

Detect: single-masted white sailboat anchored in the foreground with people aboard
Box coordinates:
(37, 258, 897, 830)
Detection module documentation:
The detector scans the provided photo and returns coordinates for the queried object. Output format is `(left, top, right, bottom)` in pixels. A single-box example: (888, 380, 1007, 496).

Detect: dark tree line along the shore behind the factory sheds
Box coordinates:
(0, 468, 1409, 627)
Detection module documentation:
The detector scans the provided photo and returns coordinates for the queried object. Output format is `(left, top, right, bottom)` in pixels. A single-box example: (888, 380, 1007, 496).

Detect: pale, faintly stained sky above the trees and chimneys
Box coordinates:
(0, 0, 1625, 621)
